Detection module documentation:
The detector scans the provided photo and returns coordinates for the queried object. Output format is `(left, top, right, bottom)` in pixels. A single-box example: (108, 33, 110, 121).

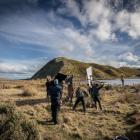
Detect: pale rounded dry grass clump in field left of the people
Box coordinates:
(22, 86, 38, 96)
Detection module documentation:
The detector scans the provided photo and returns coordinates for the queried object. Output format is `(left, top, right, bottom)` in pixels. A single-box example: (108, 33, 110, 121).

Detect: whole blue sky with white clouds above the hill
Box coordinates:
(0, 0, 140, 79)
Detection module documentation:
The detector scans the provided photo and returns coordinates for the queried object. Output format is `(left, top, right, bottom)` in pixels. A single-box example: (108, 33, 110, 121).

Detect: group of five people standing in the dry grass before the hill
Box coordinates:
(46, 75, 104, 124)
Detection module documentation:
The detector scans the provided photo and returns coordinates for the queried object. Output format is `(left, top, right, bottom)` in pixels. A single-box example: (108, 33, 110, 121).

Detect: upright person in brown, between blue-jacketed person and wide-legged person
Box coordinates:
(67, 75, 74, 104)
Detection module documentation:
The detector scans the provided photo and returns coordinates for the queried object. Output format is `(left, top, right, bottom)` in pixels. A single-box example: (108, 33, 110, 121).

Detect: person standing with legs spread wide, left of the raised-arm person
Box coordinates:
(73, 87, 88, 114)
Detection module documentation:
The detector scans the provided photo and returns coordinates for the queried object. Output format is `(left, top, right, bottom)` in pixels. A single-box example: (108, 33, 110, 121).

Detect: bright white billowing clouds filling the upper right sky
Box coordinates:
(59, 0, 140, 41)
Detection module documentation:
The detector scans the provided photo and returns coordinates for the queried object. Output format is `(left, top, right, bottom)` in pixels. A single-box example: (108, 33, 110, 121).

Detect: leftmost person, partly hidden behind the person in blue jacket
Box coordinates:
(45, 77, 53, 101)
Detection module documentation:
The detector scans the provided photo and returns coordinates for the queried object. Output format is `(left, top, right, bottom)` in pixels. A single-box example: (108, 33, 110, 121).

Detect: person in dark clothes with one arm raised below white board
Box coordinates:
(91, 83, 104, 110)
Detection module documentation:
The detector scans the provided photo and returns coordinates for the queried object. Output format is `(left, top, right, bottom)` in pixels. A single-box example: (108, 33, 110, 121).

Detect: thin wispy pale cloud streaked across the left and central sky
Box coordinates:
(0, 11, 92, 58)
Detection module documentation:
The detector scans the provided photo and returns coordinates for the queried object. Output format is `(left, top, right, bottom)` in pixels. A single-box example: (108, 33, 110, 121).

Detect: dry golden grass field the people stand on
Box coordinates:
(0, 80, 140, 140)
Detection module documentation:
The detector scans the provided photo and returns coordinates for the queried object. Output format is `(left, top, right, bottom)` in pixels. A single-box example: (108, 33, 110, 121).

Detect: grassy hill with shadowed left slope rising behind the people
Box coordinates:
(32, 57, 140, 79)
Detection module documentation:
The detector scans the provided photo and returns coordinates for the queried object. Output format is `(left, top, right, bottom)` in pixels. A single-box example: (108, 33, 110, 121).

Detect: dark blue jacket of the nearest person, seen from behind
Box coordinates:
(50, 85, 62, 102)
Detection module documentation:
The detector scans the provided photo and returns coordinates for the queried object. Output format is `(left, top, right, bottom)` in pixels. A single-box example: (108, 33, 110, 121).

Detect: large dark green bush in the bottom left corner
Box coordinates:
(0, 103, 40, 140)
